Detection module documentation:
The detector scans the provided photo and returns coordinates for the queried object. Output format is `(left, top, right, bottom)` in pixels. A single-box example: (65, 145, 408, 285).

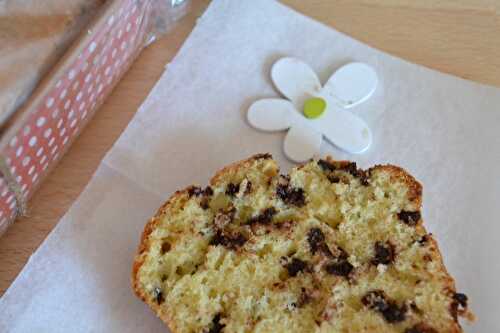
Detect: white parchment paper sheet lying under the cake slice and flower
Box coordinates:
(0, 0, 500, 332)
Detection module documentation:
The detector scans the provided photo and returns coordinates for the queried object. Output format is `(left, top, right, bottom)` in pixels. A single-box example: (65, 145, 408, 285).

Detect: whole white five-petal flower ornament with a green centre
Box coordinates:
(247, 58, 378, 162)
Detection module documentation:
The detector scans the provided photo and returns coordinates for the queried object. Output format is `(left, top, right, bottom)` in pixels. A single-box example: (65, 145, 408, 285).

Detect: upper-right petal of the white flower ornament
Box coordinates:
(321, 62, 378, 108)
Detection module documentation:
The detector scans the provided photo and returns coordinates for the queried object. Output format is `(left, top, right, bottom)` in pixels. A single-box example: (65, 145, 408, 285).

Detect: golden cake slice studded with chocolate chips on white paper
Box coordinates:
(132, 154, 473, 333)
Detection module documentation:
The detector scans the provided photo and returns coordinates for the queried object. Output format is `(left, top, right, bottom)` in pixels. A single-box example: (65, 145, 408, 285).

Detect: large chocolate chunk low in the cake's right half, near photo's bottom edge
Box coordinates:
(361, 290, 407, 323)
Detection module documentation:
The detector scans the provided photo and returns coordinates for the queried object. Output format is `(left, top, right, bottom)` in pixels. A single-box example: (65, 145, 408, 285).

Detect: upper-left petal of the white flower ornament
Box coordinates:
(271, 58, 321, 110)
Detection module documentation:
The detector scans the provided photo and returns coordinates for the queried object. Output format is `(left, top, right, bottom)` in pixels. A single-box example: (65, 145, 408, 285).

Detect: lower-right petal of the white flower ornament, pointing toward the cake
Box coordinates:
(310, 108, 372, 154)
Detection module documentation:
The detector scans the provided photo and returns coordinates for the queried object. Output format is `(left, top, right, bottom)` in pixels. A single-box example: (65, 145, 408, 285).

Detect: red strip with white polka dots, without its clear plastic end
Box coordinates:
(0, 0, 151, 234)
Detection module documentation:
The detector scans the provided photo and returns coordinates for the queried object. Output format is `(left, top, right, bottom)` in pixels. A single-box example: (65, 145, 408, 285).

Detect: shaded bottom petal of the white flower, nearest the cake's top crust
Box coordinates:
(283, 123, 323, 162)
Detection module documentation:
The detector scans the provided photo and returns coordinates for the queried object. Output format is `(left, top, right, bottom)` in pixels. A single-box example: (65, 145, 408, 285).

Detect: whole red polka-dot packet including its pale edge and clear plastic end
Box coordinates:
(0, 0, 189, 235)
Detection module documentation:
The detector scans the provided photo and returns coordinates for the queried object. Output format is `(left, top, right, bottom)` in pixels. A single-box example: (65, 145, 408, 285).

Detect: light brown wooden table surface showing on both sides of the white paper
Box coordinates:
(0, 0, 500, 295)
